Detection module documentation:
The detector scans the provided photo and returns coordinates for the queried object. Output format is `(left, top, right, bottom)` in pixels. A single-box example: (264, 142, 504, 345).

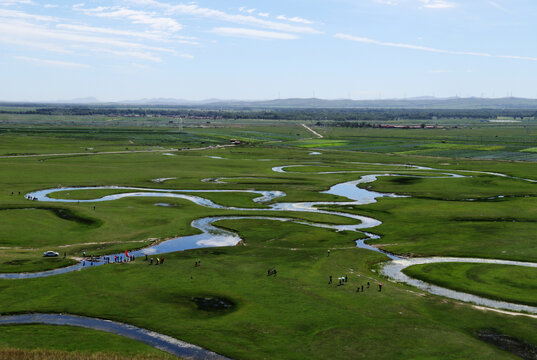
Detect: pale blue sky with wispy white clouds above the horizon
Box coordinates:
(0, 0, 537, 101)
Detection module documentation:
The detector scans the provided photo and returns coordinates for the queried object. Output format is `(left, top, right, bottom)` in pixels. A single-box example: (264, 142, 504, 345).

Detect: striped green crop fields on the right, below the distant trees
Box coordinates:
(288, 124, 537, 161)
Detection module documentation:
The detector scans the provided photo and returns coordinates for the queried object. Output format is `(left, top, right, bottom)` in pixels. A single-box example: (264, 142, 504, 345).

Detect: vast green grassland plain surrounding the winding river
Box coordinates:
(0, 124, 537, 359)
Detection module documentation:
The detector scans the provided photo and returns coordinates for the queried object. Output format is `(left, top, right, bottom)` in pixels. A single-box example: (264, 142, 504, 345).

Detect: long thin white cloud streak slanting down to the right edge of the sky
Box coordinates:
(334, 33, 537, 61)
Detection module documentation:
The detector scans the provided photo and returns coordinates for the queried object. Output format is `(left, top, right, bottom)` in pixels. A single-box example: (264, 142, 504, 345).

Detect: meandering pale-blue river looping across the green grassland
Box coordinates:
(0, 163, 537, 359)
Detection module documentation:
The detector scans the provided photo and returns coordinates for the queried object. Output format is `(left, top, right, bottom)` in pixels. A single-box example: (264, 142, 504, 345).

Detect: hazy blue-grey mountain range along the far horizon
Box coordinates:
(2, 96, 537, 110)
